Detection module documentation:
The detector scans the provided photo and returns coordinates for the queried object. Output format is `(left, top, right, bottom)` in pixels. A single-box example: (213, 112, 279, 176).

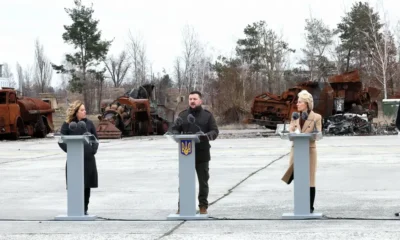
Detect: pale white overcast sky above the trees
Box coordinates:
(0, 0, 400, 86)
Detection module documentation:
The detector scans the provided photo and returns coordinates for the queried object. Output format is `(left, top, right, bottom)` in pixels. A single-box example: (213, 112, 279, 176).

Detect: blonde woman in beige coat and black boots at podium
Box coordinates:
(289, 90, 322, 213)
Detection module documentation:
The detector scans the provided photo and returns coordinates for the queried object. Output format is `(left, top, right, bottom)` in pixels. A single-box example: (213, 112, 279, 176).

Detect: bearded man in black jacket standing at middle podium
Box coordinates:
(172, 91, 219, 214)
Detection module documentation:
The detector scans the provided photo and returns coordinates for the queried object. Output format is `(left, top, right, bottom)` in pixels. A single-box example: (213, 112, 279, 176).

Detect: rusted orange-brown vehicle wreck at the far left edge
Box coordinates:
(0, 88, 55, 140)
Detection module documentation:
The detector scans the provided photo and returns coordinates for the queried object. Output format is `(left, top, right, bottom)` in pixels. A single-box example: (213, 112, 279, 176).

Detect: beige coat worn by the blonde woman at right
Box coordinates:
(282, 111, 322, 187)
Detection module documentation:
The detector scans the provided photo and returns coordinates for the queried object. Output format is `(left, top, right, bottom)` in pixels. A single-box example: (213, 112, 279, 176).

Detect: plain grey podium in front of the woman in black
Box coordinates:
(55, 135, 98, 221)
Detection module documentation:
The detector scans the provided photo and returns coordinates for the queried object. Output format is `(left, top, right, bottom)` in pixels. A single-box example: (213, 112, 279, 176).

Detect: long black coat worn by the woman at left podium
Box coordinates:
(58, 119, 99, 188)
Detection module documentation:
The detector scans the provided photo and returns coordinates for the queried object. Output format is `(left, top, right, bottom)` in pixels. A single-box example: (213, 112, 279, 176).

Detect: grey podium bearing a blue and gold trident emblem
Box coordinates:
(166, 134, 208, 220)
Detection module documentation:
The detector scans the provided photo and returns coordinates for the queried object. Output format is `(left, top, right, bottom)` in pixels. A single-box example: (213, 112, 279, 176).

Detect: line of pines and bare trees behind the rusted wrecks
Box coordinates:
(6, 0, 400, 119)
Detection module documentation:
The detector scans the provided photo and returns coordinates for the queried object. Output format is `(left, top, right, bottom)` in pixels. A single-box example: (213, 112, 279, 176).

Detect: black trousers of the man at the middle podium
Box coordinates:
(178, 162, 210, 208)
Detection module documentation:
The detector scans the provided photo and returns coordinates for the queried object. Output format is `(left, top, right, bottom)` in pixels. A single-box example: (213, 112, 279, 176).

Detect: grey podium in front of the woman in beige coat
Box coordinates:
(282, 133, 322, 219)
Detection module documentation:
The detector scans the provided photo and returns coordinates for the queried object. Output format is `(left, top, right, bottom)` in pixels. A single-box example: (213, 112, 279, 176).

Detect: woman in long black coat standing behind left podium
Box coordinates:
(58, 100, 99, 215)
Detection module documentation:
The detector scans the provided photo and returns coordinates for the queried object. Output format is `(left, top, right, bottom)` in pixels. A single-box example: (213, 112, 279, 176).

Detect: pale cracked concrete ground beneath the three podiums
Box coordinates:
(0, 130, 400, 240)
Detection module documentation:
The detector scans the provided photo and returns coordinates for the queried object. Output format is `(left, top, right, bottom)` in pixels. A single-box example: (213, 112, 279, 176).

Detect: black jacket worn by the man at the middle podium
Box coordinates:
(172, 106, 219, 163)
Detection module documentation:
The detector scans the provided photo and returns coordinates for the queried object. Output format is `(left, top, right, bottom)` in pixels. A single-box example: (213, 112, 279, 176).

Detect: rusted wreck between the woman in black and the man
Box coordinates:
(96, 84, 174, 139)
